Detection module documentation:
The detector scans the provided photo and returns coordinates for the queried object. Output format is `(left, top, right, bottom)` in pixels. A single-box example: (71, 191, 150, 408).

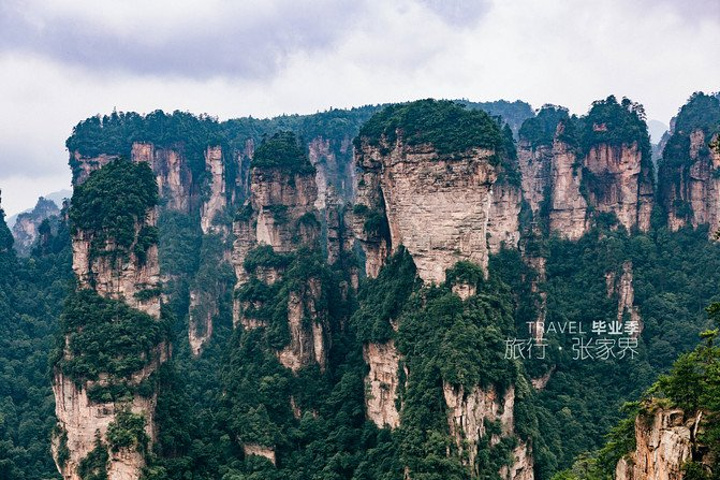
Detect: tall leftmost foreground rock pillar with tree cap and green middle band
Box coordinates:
(53, 161, 168, 480)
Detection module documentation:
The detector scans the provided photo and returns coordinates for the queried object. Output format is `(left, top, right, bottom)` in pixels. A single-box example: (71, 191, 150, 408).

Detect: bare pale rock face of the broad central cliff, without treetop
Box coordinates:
(355, 138, 500, 283)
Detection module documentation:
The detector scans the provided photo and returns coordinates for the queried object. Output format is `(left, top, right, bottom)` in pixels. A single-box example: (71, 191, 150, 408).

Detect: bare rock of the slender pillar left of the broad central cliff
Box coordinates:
(232, 158, 330, 372)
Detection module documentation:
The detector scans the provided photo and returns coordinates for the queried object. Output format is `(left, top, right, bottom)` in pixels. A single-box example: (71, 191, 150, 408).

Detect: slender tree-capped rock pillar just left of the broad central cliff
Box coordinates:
(232, 134, 329, 372)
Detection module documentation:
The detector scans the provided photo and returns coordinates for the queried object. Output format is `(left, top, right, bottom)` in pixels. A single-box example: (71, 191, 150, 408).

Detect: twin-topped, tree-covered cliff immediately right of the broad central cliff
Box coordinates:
(518, 97, 654, 240)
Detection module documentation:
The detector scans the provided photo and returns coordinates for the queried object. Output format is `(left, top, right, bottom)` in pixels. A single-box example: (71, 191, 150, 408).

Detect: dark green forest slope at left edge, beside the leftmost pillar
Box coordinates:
(0, 204, 72, 480)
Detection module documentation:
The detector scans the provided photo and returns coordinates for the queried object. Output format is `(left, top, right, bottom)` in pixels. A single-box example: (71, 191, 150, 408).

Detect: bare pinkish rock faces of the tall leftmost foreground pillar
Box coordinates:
(53, 156, 169, 480)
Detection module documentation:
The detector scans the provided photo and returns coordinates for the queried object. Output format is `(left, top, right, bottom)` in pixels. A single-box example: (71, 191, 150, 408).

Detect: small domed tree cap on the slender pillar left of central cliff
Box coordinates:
(252, 131, 315, 174)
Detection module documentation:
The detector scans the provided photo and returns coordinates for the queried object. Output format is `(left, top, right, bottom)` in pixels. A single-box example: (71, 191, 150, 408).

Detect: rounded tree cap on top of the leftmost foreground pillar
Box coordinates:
(70, 160, 158, 260)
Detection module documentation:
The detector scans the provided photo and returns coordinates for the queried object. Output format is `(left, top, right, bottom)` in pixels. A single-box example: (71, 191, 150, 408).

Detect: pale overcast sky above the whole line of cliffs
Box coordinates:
(0, 0, 720, 214)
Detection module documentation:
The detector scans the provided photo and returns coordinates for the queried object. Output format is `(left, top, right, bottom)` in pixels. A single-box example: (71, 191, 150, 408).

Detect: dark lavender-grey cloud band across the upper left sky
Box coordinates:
(0, 0, 367, 79)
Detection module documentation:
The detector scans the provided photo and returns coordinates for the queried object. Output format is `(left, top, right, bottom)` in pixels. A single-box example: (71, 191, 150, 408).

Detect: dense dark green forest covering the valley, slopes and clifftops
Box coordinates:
(0, 94, 720, 480)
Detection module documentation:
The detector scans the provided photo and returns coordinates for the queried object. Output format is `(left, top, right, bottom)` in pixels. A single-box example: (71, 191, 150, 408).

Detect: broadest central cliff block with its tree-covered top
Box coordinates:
(355, 101, 520, 283)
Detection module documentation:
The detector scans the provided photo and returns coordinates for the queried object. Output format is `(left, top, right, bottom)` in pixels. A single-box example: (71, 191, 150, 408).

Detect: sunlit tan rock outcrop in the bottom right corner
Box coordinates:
(615, 408, 711, 480)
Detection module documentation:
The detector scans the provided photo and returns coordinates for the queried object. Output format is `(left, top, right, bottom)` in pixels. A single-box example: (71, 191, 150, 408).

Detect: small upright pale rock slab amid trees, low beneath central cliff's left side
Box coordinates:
(363, 340, 400, 429)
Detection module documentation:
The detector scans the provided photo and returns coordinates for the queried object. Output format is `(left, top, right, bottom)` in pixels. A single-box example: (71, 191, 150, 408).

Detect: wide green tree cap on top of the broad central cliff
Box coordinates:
(355, 99, 503, 155)
